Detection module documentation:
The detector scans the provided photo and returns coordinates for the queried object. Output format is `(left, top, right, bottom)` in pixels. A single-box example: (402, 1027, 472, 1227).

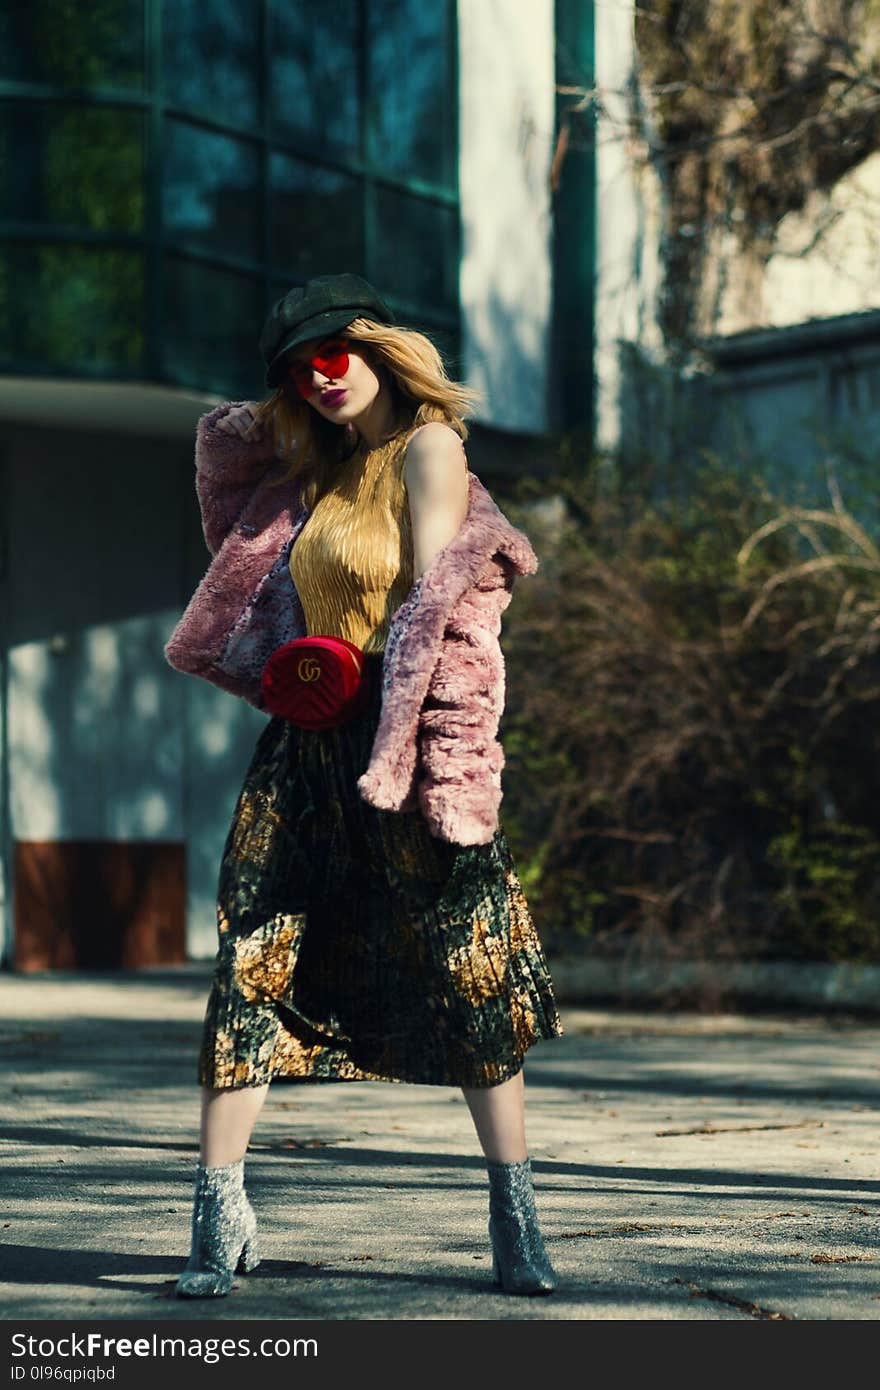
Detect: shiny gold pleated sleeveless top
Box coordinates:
(291, 434, 413, 652)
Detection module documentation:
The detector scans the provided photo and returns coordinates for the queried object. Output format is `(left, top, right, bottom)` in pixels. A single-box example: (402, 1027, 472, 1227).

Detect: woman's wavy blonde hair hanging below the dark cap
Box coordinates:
(257, 318, 478, 506)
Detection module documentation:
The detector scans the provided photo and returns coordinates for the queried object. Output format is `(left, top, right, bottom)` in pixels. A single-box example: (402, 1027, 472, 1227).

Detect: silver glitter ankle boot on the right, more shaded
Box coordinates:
(487, 1159, 557, 1294)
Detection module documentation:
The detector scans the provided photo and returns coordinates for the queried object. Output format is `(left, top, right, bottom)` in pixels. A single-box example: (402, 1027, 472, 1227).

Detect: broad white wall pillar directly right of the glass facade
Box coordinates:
(457, 0, 555, 434)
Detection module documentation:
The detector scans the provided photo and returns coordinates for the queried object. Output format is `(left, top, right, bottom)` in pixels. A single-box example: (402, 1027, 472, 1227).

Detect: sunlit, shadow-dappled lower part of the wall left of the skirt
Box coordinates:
(6, 622, 266, 958)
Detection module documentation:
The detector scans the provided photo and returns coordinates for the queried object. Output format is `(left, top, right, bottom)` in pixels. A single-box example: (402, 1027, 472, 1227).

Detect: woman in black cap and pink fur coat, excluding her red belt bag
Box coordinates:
(167, 275, 562, 1297)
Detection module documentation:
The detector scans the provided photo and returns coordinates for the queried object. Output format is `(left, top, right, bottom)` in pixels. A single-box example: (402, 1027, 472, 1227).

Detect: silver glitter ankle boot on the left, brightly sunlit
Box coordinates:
(174, 1158, 260, 1298)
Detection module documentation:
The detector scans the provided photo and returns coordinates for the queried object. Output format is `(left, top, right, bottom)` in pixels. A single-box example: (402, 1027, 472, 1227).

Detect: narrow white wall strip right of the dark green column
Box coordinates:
(595, 0, 662, 448)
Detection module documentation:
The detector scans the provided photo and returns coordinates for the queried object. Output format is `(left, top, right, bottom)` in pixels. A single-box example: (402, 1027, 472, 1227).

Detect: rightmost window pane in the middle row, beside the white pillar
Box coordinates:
(370, 189, 459, 310)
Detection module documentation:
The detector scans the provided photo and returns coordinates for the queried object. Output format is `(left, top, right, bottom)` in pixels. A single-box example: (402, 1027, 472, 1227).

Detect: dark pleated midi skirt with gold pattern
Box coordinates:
(199, 656, 562, 1088)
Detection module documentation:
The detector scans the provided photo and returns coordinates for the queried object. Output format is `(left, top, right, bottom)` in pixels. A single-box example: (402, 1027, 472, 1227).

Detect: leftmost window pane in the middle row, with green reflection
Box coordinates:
(0, 101, 143, 232)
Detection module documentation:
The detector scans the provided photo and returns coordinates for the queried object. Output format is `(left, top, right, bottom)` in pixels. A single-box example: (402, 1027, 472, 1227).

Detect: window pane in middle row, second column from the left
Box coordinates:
(163, 121, 261, 257)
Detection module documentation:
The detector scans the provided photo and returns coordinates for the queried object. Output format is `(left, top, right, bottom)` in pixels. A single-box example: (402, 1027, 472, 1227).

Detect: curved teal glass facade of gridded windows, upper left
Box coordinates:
(0, 0, 459, 393)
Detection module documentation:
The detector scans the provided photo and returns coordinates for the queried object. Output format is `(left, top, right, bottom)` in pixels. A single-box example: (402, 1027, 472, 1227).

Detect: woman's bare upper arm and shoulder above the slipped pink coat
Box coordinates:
(403, 421, 468, 578)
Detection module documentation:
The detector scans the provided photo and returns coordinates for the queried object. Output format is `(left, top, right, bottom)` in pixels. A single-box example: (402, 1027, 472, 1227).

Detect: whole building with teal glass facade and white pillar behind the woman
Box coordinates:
(0, 0, 594, 970)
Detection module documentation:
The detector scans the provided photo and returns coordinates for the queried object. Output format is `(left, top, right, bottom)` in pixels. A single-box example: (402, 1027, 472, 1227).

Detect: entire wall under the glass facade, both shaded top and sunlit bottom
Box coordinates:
(0, 427, 266, 958)
